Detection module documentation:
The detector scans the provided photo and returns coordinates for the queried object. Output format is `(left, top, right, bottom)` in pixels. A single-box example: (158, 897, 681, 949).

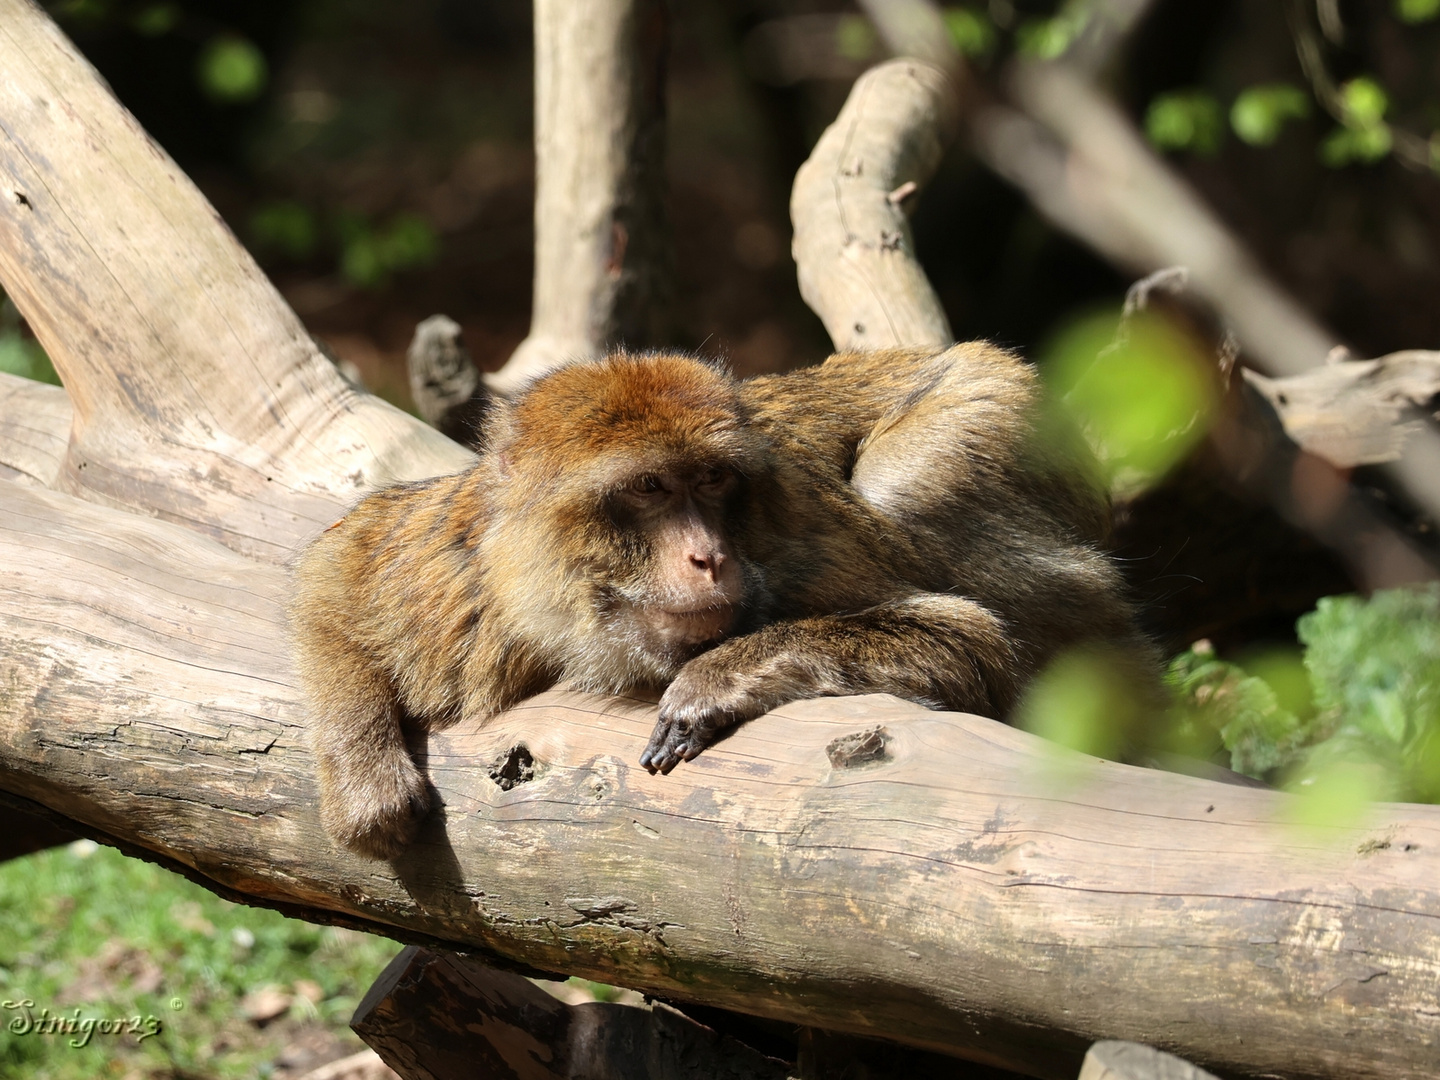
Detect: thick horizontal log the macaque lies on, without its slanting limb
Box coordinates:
(0, 484, 1440, 1080)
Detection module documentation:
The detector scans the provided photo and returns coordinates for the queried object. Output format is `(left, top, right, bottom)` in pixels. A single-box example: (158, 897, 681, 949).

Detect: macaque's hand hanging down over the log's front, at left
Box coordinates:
(320, 753, 431, 860)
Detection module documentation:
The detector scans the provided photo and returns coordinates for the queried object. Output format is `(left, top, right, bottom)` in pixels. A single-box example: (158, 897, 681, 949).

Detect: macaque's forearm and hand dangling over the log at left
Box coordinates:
(301, 635, 431, 860)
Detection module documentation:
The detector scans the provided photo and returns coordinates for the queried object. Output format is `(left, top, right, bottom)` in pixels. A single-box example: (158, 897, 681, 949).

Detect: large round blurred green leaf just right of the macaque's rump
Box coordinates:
(1043, 312, 1215, 491)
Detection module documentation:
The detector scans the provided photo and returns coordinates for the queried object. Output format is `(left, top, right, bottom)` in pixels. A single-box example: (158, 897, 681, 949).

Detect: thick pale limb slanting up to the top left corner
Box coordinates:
(0, 0, 469, 562)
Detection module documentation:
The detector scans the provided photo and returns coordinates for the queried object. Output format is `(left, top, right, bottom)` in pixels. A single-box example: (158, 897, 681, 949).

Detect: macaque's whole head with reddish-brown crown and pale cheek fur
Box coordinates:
(482, 354, 768, 690)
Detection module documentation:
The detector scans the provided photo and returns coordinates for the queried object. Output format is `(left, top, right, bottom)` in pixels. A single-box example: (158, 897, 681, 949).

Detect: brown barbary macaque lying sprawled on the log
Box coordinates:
(292, 343, 1152, 858)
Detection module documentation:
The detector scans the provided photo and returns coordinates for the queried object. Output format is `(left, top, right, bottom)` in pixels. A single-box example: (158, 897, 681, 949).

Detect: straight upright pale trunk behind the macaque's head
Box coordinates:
(487, 0, 670, 393)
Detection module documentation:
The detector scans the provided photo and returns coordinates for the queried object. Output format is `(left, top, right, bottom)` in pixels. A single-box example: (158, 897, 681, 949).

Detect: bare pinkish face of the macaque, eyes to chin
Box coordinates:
(606, 464, 746, 668)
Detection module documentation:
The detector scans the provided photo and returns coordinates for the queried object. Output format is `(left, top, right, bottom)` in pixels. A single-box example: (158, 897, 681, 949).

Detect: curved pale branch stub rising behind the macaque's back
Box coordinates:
(791, 59, 956, 350)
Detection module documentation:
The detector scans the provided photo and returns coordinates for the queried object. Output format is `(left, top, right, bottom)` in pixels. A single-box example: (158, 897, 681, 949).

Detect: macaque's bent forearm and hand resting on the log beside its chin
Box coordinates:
(641, 593, 1020, 772)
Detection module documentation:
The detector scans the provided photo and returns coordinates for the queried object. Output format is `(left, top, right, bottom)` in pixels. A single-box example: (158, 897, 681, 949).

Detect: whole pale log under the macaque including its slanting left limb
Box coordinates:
(0, 0, 1440, 1080)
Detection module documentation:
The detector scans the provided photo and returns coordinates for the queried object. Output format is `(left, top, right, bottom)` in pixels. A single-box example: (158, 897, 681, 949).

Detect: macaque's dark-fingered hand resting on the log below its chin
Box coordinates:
(639, 648, 804, 773)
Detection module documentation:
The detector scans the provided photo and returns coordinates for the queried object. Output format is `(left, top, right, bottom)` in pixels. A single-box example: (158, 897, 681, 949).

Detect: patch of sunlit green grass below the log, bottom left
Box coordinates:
(0, 841, 397, 1080)
